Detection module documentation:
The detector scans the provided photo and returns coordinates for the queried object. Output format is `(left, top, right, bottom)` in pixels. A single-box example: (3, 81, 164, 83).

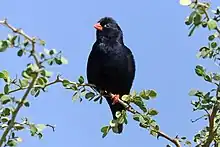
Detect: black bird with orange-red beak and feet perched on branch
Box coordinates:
(87, 17, 135, 133)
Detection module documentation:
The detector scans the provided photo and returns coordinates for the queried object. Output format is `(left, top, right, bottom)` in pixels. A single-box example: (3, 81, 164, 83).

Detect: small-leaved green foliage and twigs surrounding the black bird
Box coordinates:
(0, 0, 220, 147)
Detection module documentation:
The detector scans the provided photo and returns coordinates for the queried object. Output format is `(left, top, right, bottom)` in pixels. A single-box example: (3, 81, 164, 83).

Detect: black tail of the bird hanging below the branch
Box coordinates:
(106, 96, 125, 134)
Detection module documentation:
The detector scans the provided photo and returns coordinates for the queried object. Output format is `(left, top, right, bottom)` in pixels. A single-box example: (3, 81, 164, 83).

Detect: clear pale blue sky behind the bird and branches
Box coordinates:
(0, 0, 217, 147)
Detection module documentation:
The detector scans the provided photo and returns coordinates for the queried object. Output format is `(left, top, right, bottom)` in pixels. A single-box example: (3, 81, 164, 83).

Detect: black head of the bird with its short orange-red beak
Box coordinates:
(94, 17, 123, 43)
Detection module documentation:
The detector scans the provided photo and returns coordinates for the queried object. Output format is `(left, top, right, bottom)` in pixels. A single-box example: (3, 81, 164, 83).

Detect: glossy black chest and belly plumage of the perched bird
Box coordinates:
(88, 43, 130, 93)
